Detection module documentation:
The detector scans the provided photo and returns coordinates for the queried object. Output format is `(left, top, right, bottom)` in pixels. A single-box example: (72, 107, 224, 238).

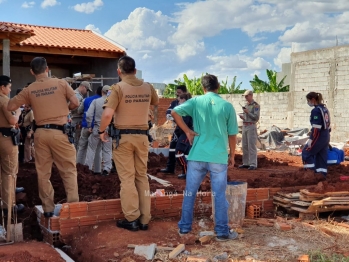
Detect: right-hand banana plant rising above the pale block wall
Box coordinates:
(250, 69, 290, 93)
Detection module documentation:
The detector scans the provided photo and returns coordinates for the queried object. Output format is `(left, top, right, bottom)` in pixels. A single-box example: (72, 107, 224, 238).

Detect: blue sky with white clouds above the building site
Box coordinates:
(0, 0, 349, 89)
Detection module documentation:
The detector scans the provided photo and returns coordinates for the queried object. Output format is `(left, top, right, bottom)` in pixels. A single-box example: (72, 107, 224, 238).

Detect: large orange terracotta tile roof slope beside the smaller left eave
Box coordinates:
(0, 23, 125, 53)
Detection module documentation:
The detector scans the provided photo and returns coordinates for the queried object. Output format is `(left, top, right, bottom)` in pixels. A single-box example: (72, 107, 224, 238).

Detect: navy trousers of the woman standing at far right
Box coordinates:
(302, 130, 330, 175)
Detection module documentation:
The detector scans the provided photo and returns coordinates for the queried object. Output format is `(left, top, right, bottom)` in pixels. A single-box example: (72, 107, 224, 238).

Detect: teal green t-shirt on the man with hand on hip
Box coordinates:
(173, 92, 239, 164)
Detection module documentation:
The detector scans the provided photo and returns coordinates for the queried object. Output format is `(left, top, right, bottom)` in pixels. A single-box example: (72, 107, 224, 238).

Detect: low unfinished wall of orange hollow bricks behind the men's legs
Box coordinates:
(36, 187, 312, 245)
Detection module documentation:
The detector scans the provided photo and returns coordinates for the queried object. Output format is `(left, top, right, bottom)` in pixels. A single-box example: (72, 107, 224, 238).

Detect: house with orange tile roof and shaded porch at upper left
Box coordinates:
(0, 22, 126, 95)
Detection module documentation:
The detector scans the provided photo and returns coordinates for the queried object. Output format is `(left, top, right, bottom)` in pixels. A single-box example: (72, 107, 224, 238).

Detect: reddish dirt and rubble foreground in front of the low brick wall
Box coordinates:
(66, 218, 349, 262)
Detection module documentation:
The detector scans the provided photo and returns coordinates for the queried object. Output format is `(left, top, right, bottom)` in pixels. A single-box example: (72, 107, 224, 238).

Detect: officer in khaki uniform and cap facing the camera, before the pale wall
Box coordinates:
(239, 90, 260, 170)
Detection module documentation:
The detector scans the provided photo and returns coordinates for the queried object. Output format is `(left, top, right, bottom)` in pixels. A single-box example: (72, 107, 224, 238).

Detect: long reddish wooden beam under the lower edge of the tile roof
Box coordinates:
(11, 45, 123, 59)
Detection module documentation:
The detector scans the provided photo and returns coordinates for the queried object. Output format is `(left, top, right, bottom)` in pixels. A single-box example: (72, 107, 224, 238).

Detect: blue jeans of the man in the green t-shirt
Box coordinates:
(178, 161, 229, 236)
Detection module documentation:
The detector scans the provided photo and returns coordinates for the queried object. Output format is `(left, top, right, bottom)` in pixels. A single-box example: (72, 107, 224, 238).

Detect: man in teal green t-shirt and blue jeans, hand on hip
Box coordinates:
(171, 75, 238, 241)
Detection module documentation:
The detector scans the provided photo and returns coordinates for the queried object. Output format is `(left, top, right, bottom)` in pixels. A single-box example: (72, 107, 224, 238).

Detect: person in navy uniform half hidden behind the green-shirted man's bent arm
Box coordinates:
(174, 93, 193, 179)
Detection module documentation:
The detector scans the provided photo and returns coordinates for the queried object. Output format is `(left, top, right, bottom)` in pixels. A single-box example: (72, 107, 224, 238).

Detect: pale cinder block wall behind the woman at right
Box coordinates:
(158, 45, 349, 142)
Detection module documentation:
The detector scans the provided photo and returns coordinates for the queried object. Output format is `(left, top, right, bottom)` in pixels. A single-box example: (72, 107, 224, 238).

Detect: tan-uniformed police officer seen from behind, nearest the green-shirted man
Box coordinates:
(99, 56, 159, 231)
